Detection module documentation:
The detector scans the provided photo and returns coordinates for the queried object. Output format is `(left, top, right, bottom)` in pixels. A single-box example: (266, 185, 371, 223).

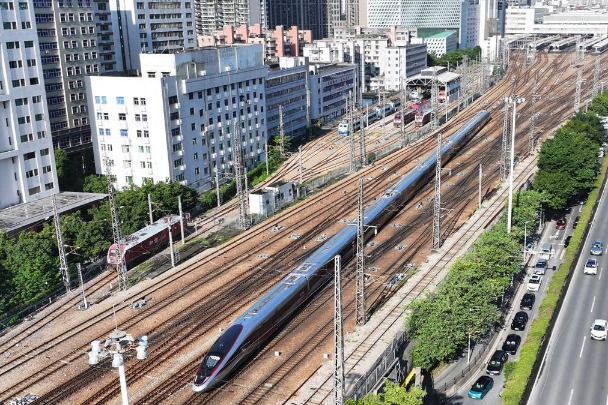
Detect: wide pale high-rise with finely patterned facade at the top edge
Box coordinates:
(367, 0, 479, 48)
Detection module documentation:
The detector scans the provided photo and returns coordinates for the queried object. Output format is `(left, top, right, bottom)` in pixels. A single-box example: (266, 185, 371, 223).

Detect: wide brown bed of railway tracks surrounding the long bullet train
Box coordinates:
(0, 52, 608, 404)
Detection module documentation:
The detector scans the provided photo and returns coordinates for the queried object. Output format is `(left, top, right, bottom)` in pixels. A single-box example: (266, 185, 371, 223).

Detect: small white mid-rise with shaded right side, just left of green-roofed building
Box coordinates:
(380, 43, 427, 91)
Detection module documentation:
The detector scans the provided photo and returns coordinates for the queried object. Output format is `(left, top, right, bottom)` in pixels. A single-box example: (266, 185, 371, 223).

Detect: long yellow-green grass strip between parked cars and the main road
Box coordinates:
(502, 159, 608, 405)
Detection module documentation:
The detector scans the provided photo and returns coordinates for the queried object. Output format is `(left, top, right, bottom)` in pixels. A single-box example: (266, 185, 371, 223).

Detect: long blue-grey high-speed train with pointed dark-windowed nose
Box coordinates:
(192, 110, 490, 392)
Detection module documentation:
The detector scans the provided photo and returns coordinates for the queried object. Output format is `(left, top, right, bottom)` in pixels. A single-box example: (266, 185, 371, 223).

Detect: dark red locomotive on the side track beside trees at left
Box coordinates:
(107, 215, 181, 267)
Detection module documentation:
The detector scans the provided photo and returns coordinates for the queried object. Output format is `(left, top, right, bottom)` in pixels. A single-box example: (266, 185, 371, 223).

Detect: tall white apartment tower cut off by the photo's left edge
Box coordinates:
(0, 0, 59, 208)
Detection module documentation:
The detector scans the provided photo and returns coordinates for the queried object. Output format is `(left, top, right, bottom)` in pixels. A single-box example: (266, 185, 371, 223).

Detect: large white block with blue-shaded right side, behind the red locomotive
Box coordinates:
(86, 45, 268, 192)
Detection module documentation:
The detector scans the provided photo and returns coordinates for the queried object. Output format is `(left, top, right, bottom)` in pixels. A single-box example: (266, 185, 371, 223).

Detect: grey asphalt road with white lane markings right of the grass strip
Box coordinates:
(528, 192, 608, 405)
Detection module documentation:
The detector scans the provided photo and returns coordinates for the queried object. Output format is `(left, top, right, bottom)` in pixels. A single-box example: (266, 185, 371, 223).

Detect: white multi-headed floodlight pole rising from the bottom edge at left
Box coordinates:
(87, 329, 148, 405)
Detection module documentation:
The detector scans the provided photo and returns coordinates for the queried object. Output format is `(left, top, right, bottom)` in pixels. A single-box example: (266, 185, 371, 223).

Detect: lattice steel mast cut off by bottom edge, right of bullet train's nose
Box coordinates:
(334, 256, 344, 405)
